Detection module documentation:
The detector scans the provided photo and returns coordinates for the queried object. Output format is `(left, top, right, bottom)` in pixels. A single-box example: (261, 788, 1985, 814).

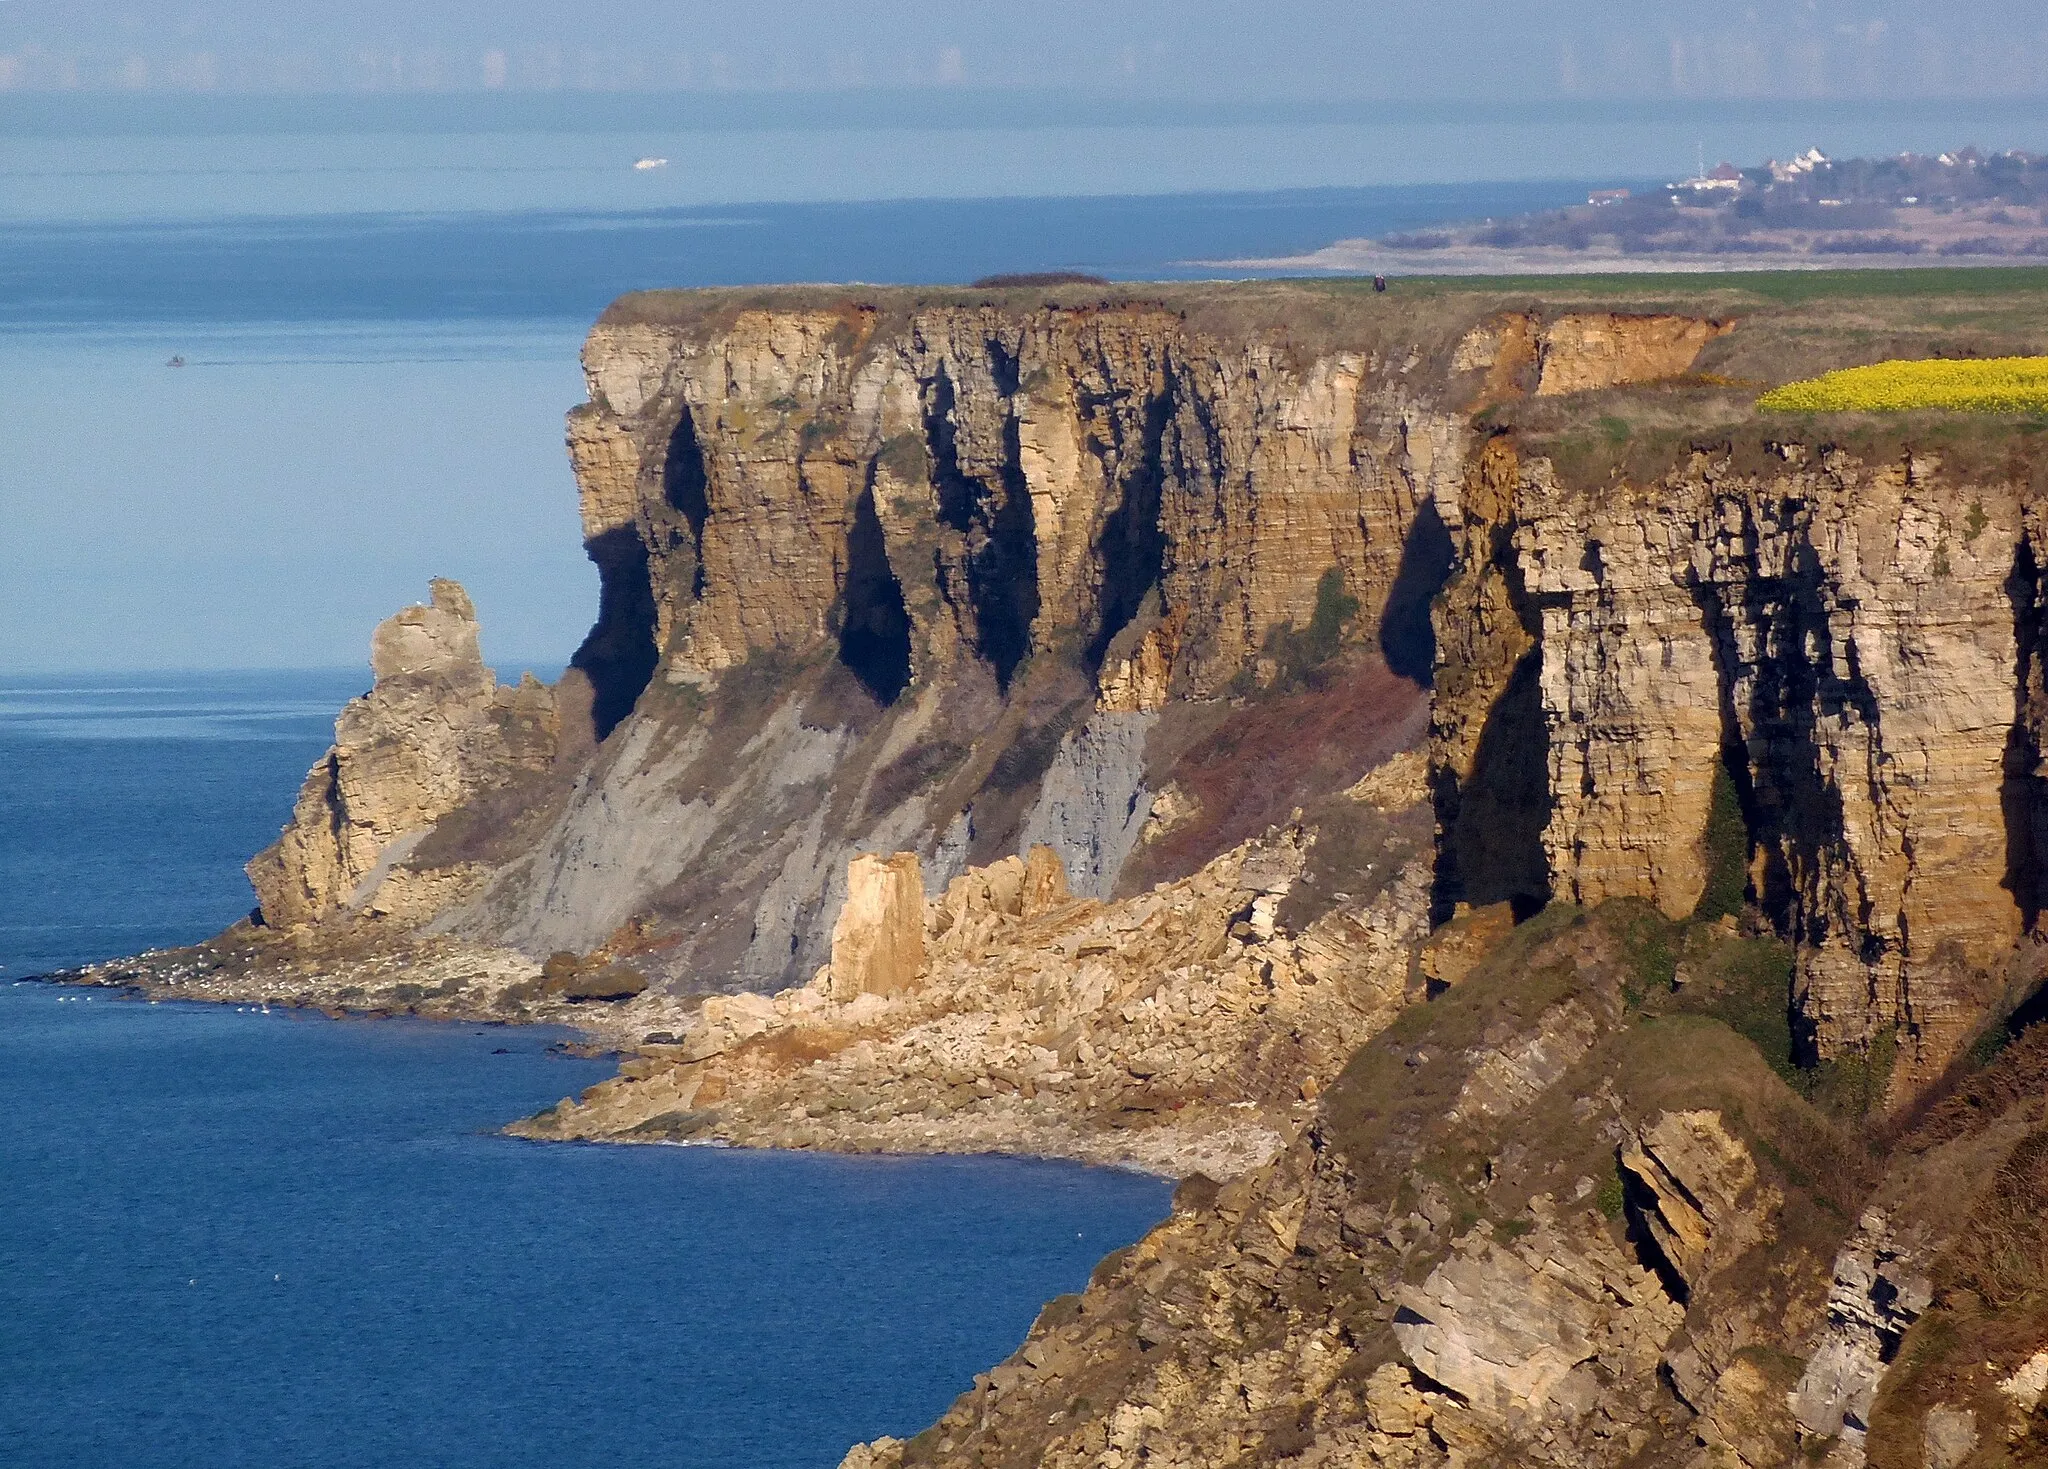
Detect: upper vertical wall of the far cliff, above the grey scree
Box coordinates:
(569, 301, 1462, 697)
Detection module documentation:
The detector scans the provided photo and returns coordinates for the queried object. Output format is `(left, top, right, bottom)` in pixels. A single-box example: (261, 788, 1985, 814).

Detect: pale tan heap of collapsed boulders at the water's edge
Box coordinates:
(516, 811, 1425, 1178)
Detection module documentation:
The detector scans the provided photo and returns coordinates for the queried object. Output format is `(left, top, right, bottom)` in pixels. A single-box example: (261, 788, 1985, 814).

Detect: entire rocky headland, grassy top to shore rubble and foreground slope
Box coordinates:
(79, 272, 2048, 1469)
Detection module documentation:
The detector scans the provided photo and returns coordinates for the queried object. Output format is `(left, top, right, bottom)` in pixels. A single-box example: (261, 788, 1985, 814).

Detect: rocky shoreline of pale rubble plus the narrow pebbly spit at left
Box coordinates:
(68, 737, 1427, 1178)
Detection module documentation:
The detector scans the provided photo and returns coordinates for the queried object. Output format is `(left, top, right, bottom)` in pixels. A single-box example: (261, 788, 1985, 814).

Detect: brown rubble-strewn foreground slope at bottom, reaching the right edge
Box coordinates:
(846, 904, 2048, 1469)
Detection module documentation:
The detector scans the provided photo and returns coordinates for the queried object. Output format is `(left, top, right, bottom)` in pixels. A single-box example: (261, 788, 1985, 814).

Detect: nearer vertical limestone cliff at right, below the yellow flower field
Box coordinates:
(1436, 438, 2034, 1078)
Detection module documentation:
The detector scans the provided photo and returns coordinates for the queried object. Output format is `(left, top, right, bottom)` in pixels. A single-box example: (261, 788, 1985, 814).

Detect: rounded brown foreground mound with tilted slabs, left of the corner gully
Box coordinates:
(831, 918, 1875, 1469)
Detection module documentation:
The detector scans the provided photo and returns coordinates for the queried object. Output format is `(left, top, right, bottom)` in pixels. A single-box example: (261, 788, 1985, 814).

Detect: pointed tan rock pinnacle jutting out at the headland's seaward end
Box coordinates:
(248, 580, 559, 928)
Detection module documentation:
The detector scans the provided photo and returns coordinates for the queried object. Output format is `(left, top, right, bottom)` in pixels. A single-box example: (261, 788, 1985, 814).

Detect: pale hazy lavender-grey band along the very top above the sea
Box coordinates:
(12, 0, 2048, 98)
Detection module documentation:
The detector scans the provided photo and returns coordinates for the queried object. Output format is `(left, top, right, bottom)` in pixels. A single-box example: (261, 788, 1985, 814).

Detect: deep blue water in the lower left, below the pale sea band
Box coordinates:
(0, 672, 1167, 1469)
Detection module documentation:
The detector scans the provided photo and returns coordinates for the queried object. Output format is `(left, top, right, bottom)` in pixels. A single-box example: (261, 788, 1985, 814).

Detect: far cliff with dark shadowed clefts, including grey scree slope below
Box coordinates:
(303, 293, 1515, 990)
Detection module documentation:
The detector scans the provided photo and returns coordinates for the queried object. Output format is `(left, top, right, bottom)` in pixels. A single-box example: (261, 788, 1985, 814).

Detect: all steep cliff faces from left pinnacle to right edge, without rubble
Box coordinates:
(252, 291, 2048, 1094)
